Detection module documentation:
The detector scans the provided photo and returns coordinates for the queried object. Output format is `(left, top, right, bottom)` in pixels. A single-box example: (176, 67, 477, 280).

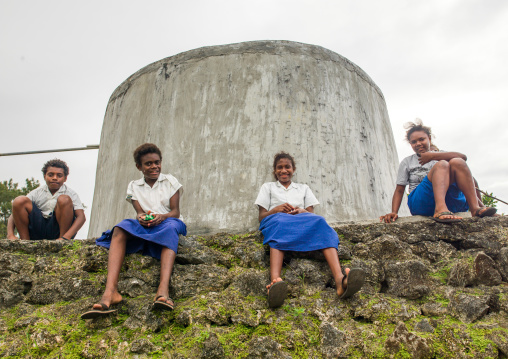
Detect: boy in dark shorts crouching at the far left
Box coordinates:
(7, 159, 86, 240)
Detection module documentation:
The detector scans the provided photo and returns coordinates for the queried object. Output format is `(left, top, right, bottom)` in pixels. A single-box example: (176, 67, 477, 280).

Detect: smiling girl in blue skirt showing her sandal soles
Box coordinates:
(255, 152, 365, 308)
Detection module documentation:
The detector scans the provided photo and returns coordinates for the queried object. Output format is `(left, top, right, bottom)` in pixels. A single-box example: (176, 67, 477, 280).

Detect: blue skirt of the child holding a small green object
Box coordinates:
(95, 218, 187, 260)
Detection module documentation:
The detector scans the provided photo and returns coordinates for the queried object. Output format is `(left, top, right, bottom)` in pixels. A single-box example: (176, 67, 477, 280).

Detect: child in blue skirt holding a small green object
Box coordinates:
(81, 143, 187, 319)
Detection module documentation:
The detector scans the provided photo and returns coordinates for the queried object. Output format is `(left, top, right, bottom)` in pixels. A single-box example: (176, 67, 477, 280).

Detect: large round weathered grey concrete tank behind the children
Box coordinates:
(89, 41, 408, 236)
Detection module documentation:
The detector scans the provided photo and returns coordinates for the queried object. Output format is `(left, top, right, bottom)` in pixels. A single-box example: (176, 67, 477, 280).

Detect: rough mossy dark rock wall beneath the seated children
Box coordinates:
(0, 217, 508, 358)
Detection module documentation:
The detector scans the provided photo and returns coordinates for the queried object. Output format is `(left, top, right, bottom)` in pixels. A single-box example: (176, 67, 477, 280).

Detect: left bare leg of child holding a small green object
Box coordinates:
(93, 227, 129, 310)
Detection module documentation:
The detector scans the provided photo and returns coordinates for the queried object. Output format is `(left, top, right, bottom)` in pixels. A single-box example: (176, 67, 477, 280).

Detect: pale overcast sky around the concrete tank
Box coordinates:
(0, 0, 508, 238)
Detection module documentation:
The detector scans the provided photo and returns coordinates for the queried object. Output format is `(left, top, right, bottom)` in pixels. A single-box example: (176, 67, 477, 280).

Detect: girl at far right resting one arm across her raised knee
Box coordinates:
(379, 119, 497, 223)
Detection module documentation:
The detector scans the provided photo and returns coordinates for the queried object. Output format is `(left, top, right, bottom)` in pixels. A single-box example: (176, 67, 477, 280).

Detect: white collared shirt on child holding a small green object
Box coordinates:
(126, 173, 183, 219)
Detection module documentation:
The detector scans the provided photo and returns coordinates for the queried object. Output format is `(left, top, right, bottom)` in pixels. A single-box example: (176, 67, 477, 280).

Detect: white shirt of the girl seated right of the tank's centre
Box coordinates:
(254, 181, 319, 211)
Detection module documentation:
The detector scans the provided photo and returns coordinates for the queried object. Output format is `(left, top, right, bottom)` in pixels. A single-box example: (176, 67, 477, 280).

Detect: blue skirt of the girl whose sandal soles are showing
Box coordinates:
(259, 213, 339, 252)
